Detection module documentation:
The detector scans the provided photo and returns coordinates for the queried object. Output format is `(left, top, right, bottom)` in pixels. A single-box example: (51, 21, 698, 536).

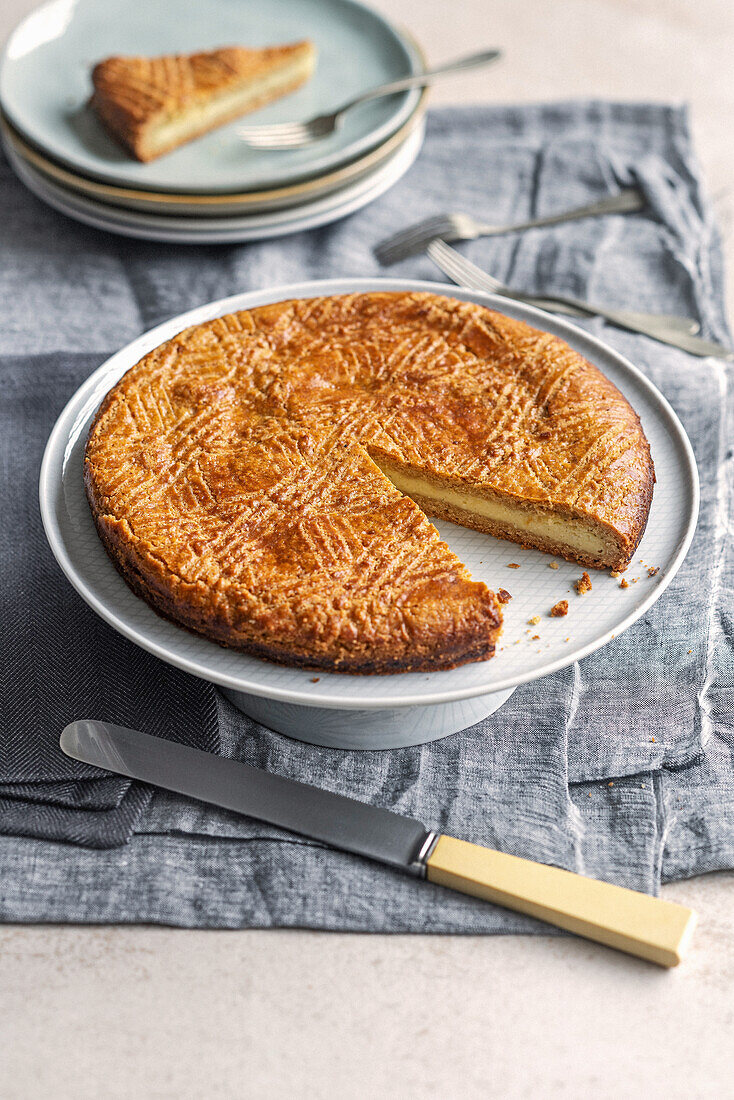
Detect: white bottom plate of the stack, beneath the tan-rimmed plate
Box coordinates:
(3, 123, 425, 244)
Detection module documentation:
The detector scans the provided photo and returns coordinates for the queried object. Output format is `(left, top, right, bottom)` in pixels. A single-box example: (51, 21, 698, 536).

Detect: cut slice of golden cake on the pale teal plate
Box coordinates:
(91, 41, 316, 161)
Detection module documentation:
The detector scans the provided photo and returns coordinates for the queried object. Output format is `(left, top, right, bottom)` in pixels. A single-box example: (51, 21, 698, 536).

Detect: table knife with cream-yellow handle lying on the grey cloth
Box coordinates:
(61, 721, 695, 967)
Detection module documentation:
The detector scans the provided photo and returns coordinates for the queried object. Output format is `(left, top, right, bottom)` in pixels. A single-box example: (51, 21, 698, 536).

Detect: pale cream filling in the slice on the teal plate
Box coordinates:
(149, 55, 313, 147)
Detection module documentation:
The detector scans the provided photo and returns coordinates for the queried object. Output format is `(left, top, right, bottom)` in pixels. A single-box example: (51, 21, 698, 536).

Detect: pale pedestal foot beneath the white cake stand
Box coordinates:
(219, 688, 514, 749)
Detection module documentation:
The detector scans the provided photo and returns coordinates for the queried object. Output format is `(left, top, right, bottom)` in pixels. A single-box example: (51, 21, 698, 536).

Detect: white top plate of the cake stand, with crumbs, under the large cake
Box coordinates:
(40, 279, 699, 708)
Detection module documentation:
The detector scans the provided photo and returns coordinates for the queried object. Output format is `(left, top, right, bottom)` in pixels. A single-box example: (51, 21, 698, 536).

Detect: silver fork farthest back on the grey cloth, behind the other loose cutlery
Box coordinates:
(374, 187, 645, 266)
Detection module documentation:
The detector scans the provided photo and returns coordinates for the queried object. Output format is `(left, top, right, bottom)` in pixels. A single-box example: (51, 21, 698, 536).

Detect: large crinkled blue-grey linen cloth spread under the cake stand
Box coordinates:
(0, 102, 734, 932)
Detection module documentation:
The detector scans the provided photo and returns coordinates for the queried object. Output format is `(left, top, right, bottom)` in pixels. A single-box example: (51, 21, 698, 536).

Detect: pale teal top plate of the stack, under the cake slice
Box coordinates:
(0, 0, 421, 194)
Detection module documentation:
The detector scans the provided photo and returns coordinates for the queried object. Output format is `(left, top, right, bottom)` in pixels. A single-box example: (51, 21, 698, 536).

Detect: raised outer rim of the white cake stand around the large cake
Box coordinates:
(39, 277, 700, 711)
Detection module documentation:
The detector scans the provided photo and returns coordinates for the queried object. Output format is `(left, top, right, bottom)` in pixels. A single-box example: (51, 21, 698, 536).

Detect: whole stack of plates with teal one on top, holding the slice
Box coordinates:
(0, 0, 425, 244)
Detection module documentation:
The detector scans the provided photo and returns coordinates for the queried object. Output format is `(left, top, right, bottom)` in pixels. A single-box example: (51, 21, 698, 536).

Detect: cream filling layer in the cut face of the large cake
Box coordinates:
(381, 466, 606, 558)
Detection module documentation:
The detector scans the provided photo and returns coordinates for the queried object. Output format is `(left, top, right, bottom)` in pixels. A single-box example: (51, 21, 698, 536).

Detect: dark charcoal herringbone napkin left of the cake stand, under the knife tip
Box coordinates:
(0, 355, 218, 848)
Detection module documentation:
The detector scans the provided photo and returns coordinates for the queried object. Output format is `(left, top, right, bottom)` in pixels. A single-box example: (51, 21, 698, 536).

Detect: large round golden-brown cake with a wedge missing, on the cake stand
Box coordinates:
(85, 293, 655, 672)
